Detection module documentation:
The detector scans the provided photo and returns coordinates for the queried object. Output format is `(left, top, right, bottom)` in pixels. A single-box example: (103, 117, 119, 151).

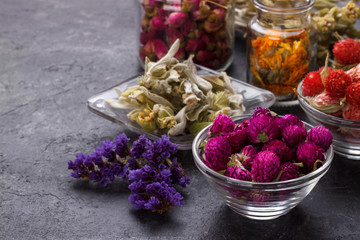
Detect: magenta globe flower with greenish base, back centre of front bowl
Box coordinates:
(248, 115, 280, 143)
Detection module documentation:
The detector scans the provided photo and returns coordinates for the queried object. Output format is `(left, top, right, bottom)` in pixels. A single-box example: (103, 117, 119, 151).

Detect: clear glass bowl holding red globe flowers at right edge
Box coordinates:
(297, 82, 360, 160)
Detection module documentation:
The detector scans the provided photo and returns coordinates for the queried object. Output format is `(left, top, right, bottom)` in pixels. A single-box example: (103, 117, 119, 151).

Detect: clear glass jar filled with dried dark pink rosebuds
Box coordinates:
(138, 0, 235, 71)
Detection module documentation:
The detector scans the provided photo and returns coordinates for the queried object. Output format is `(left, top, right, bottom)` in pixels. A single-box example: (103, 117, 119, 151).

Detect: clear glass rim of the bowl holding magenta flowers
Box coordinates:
(192, 114, 334, 189)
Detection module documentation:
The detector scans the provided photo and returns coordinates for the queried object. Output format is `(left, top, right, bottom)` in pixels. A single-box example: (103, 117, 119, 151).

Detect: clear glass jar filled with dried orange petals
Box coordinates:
(247, 0, 317, 101)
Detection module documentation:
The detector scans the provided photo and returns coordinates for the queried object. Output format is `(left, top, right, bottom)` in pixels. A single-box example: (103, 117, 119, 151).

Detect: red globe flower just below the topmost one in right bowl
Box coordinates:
(325, 69, 352, 98)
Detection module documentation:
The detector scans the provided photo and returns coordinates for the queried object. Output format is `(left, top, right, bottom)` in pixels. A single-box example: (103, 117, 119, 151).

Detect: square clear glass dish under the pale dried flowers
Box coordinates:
(87, 65, 275, 150)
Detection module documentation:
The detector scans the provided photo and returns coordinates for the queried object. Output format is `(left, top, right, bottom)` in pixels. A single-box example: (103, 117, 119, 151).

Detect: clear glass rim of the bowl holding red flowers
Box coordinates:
(297, 80, 360, 128)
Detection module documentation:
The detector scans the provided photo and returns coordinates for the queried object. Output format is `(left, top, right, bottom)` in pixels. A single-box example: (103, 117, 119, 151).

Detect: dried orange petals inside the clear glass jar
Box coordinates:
(250, 30, 310, 95)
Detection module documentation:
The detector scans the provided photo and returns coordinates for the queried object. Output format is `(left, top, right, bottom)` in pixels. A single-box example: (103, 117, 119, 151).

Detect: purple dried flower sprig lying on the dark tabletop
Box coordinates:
(68, 133, 190, 213)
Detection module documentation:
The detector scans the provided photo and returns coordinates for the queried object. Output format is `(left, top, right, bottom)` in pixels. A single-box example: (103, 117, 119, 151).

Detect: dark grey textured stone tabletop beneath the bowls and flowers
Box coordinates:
(0, 0, 360, 240)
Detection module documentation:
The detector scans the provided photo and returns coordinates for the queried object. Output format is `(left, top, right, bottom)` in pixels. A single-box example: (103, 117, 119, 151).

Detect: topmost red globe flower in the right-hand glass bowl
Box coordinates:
(333, 38, 360, 65)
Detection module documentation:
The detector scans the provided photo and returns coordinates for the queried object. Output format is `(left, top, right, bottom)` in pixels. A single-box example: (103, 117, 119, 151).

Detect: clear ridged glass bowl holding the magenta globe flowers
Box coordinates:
(192, 115, 334, 220)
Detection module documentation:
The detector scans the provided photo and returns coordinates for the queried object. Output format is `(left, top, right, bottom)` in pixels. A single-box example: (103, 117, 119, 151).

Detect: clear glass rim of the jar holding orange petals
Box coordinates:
(254, 0, 315, 14)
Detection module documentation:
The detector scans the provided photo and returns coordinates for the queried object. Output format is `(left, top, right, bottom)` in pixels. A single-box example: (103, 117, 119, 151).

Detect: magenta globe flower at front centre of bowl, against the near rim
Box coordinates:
(251, 151, 280, 182)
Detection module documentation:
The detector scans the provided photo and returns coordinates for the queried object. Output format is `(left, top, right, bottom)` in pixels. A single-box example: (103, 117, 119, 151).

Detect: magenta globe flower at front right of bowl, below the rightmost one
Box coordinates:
(296, 142, 325, 173)
